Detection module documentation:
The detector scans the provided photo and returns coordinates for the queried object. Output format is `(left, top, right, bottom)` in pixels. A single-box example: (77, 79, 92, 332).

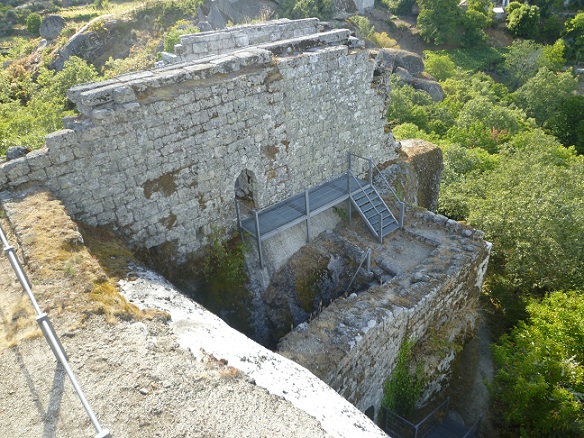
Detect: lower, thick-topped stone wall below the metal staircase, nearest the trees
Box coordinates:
(278, 212, 490, 415)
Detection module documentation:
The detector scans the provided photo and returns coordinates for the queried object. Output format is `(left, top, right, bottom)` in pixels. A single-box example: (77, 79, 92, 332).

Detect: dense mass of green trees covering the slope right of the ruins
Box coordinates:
(388, 41, 584, 436)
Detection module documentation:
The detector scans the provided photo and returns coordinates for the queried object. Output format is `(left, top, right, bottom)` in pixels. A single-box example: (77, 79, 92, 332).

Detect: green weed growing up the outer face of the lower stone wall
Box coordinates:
(381, 339, 424, 419)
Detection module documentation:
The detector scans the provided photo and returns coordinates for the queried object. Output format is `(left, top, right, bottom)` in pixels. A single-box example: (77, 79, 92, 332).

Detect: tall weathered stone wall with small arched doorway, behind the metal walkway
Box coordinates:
(0, 20, 397, 260)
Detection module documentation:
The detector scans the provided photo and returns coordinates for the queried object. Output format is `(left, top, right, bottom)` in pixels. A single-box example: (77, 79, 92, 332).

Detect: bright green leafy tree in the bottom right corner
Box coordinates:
(492, 292, 584, 437)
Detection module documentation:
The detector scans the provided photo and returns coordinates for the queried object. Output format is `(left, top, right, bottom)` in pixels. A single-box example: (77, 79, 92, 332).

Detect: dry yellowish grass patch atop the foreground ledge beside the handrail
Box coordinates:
(0, 186, 168, 348)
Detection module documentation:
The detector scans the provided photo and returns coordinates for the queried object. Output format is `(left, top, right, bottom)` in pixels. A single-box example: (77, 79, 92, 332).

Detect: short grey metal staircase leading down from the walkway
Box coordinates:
(351, 184, 400, 243)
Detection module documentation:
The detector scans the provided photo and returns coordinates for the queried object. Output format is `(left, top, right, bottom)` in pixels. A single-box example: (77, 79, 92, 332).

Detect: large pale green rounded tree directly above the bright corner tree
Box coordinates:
(468, 129, 584, 293)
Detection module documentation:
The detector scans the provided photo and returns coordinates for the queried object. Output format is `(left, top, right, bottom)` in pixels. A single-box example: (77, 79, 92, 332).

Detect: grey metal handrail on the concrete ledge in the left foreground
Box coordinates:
(0, 225, 111, 438)
